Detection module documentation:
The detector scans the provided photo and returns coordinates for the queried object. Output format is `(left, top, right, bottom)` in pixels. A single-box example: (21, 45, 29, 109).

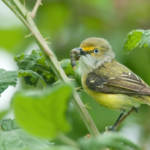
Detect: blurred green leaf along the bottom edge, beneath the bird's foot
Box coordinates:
(79, 133, 140, 150)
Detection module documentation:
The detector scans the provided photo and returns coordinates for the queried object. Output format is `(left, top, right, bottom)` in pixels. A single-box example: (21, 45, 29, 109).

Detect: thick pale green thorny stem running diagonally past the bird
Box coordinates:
(2, 0, 100, 136)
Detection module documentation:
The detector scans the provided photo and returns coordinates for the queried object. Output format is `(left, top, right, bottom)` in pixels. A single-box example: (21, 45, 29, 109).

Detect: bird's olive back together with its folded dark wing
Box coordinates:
(86, 60, 150, 95)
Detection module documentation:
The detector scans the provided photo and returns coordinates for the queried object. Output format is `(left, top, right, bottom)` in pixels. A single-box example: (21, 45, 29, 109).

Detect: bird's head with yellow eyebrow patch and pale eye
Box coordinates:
(72, 37, 115, 73)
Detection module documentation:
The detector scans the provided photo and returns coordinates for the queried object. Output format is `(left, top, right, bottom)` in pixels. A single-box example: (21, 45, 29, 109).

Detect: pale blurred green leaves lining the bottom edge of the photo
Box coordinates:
(0, 119, 140, 150)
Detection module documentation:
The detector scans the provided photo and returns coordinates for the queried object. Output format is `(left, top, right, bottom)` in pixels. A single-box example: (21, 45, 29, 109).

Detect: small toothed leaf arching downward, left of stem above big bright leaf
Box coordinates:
(18, 70, 46, 86)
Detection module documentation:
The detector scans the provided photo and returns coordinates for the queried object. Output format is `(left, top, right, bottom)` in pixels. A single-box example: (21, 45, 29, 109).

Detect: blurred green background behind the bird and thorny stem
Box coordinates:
(0, 0, 150, 149)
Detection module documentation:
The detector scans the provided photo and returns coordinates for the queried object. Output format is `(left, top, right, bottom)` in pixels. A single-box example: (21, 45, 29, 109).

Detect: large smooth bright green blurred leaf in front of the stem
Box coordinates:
(13, 84, 72, 138)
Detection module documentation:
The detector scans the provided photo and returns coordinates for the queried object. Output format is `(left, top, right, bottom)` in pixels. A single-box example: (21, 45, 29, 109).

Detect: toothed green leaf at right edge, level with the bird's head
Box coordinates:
(123, 30, 150, 52)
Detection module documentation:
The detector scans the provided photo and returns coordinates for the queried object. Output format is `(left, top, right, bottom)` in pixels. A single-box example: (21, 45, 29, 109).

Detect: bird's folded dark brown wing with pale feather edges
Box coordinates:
(85, 67, 150, 95)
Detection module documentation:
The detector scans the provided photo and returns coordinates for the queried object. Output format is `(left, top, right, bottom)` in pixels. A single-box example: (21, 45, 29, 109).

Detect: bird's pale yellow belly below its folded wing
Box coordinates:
(85, 88, 141, 111)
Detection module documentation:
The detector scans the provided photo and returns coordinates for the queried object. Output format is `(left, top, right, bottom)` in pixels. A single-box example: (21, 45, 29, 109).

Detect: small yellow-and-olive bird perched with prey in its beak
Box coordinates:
(71, 37, 150, 131)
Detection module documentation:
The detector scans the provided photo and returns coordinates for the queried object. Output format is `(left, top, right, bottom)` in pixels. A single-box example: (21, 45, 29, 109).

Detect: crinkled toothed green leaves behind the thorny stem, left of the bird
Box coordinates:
(0, 50, 81, 94)
